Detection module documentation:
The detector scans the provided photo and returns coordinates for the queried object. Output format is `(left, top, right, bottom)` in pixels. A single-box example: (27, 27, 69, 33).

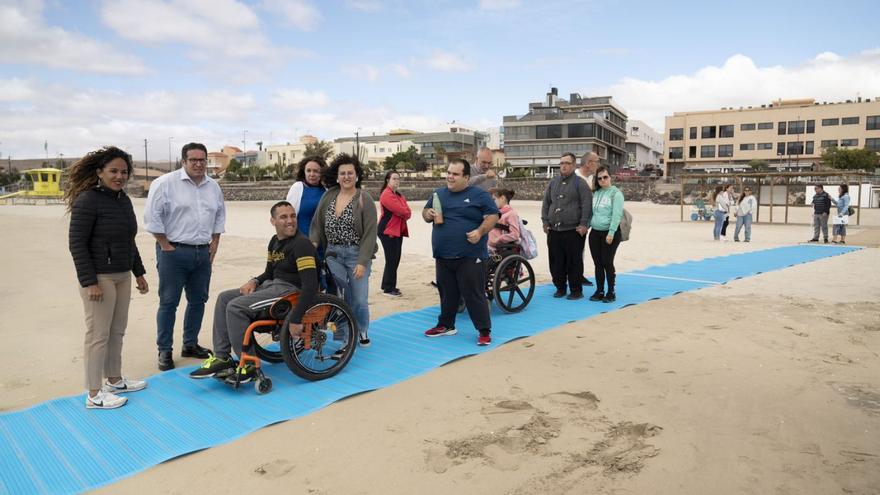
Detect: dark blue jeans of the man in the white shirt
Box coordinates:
(156, 243, 211, 351)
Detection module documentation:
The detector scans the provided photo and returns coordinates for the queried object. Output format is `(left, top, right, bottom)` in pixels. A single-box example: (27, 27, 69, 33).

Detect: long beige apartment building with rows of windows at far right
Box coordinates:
(665, 97, 880, 176)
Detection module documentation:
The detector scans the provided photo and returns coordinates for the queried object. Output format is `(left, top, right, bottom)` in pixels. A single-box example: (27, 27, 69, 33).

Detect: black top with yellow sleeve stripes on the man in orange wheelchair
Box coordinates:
(255, 231, 318, 323)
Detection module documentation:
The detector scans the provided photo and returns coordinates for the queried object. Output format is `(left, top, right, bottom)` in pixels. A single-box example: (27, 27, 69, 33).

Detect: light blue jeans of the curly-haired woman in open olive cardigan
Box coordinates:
(325, 244, 372, 338)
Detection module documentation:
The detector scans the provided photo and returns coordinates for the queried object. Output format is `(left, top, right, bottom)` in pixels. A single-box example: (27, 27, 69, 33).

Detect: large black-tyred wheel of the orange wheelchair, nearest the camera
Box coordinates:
(281, 294, 357, 381)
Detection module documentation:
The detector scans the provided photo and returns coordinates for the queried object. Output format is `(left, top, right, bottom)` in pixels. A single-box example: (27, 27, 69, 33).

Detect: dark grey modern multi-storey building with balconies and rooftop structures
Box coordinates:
(504, 88, 626, 174)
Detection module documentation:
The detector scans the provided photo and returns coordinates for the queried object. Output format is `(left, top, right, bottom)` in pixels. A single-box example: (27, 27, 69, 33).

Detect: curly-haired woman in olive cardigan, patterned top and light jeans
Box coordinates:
(310, 153, 378, 347)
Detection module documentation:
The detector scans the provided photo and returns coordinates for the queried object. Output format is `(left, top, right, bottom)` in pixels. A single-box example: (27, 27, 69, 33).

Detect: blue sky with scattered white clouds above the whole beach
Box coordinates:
(0, 0, 880, 159)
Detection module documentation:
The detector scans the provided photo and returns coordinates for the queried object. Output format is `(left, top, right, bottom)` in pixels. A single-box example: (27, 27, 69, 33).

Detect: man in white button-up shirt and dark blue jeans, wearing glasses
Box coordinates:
(144, 143, 226, 371)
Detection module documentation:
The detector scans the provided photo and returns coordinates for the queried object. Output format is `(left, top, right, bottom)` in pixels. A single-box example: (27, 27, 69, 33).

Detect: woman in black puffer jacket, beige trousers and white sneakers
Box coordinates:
(64, 147, 149, 409)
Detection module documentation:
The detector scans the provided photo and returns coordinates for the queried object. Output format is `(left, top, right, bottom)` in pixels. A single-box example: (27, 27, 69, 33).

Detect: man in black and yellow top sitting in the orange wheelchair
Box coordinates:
(190, 201, 318, 383)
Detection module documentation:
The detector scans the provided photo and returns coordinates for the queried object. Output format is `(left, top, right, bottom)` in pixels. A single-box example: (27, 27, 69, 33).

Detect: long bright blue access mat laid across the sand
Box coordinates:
(0, 245, 858, 494)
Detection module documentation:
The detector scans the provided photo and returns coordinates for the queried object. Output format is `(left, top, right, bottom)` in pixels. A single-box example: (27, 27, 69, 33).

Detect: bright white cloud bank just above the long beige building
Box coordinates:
(583, 49, 880, 130)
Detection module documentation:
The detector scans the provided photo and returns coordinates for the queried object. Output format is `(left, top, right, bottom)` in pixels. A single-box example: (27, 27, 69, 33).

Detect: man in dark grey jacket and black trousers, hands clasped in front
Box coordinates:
(541, 153, 593, 300)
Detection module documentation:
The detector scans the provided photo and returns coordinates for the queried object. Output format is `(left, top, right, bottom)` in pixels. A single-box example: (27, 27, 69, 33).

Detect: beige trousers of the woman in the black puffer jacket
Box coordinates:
(79, 272, 131, 390)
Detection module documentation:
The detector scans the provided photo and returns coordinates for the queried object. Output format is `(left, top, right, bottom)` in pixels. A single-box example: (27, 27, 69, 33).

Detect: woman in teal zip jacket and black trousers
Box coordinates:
(589, 165, 623, 303)
